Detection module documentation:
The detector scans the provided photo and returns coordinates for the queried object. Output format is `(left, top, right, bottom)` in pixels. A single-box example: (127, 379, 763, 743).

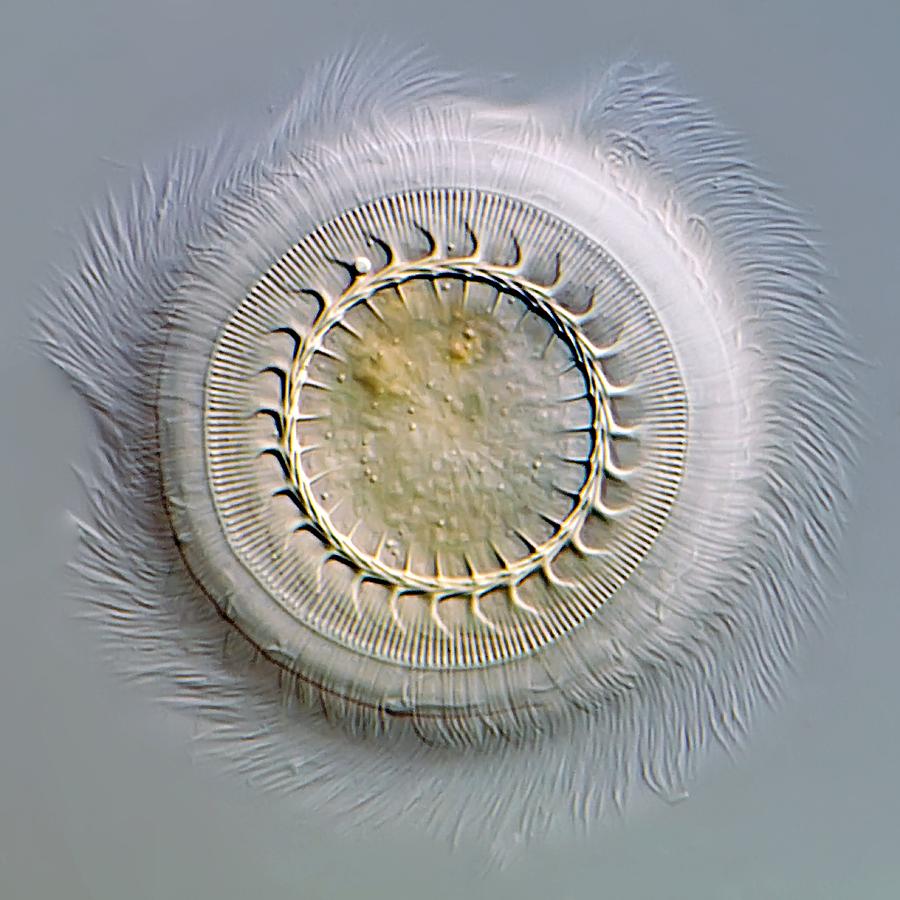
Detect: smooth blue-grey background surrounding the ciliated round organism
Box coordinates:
(0, 0, 900, 900)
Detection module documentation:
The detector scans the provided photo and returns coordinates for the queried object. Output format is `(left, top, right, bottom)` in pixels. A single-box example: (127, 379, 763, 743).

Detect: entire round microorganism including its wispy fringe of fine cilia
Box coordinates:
(39, 47, 856, 852)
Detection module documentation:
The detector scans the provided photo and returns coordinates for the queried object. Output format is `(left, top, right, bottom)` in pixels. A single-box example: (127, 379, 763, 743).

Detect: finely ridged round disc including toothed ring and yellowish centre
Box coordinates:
(163, 190, 687, 724)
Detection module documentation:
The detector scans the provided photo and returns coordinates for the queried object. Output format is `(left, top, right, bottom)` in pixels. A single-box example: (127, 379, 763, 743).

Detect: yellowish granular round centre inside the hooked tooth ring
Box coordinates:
(296, 276, 592, 575)
